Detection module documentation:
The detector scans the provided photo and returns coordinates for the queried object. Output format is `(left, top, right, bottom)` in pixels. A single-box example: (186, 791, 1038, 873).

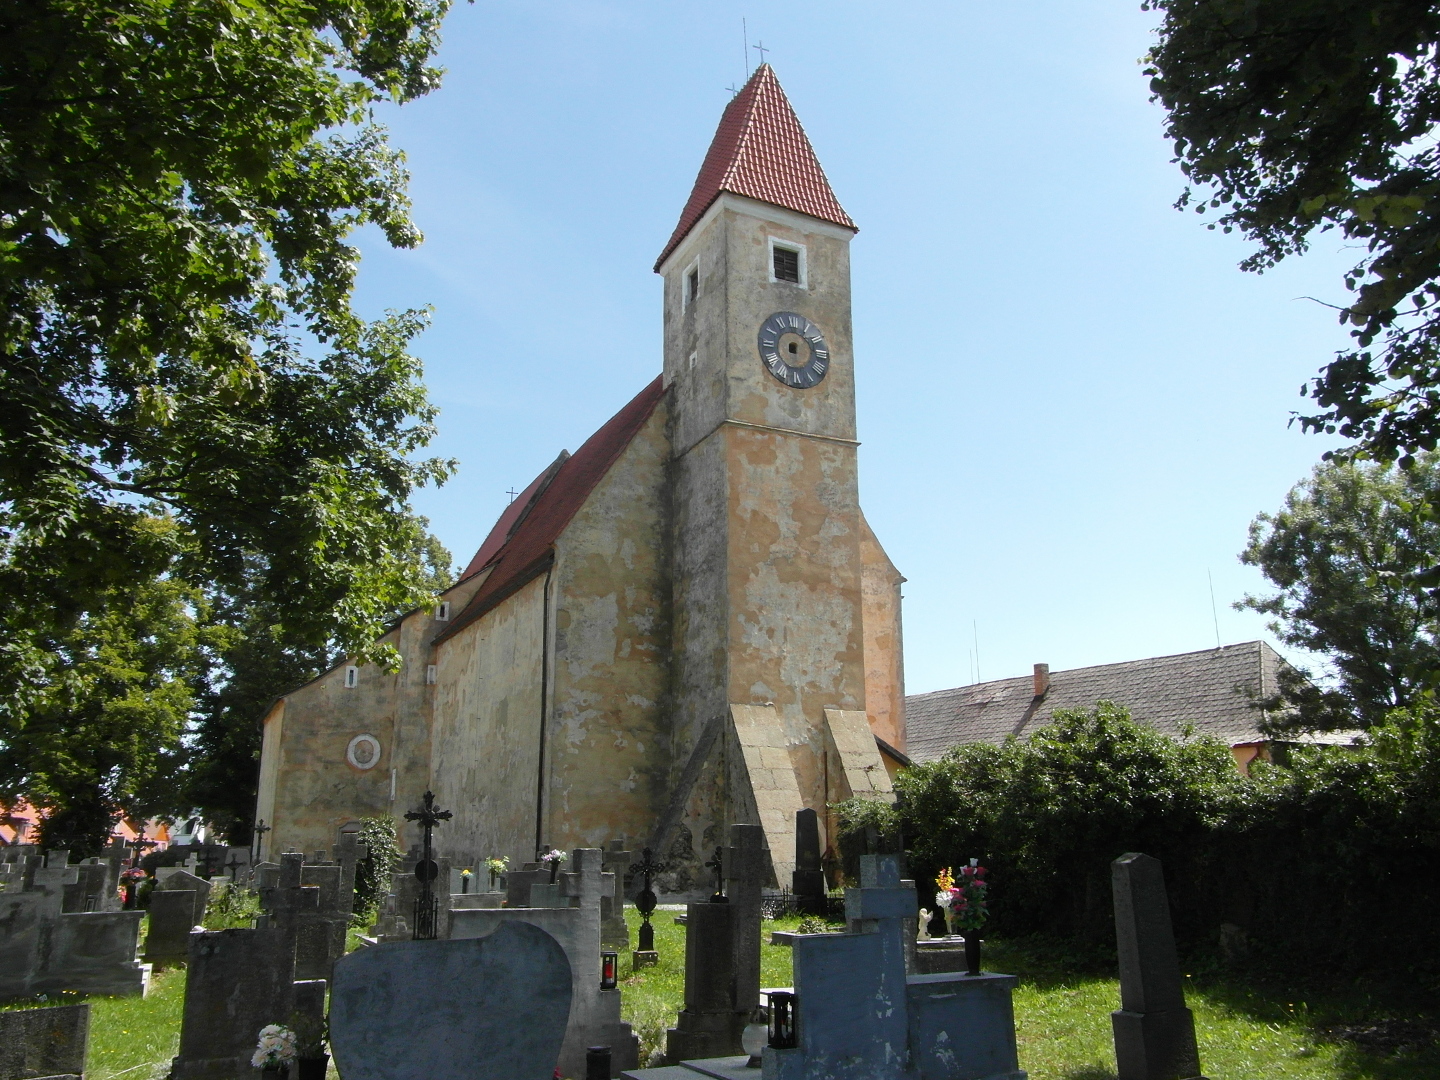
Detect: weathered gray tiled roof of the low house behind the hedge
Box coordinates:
(904, 641, 1286, 762)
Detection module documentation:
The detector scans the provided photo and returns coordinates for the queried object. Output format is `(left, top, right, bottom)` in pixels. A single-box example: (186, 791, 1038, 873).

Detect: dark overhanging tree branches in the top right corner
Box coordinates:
(1145, 0, 1440, 464)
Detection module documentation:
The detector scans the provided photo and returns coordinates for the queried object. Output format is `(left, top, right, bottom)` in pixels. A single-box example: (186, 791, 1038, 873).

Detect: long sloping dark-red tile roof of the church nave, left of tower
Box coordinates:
(435, 376, 665, 642)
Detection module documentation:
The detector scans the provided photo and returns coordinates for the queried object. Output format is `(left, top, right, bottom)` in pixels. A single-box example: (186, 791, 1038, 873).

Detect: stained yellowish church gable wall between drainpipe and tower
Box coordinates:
(544, 402, 671, 850)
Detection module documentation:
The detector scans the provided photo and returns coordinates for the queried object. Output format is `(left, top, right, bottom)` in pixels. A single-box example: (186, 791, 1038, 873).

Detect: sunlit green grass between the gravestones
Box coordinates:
(14, 910, 1440, 1080)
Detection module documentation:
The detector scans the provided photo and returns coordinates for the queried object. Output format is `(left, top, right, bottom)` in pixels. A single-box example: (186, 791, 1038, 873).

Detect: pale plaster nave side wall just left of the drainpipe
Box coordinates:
(431, 575, 549, 865)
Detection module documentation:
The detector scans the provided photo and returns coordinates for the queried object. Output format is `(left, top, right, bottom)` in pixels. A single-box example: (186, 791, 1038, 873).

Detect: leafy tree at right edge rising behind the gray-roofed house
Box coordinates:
(1236, 454, 1440, 729)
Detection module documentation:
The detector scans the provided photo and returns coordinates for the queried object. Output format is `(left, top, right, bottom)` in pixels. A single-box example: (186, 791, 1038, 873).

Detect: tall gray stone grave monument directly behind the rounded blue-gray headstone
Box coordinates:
(451, 848, 639, 1077)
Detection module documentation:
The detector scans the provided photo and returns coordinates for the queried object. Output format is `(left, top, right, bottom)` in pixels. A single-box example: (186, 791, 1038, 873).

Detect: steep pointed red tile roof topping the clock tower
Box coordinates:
(655, 63, 855, 271)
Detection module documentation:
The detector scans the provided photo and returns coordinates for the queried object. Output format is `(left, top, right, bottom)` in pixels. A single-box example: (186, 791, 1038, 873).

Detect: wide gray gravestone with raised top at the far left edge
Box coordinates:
(0, 855, 150, 999)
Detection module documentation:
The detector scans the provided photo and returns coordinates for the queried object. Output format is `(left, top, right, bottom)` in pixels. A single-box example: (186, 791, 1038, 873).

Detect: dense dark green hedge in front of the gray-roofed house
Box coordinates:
(875, 703, 1440, 984)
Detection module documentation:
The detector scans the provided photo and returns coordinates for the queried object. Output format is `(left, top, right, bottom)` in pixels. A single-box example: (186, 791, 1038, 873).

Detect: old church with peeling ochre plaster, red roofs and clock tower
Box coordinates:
(256, 65, 906, 891)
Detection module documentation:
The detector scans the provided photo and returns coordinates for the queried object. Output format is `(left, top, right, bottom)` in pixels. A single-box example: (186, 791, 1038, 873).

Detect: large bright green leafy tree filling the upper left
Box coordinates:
(0, 0, 449, 743)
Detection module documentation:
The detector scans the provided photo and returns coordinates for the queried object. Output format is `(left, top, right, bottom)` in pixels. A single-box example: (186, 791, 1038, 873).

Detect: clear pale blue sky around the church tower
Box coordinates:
(345, 0, 1354, 693)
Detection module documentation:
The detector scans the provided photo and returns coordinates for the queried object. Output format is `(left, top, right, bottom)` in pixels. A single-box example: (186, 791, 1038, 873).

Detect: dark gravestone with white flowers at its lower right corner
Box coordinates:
(170, 929, 295, 1080)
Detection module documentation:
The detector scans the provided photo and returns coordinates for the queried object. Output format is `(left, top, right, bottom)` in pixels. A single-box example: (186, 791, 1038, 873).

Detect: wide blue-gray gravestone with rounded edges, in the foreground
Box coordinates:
(330, 922, 570, 1080)
